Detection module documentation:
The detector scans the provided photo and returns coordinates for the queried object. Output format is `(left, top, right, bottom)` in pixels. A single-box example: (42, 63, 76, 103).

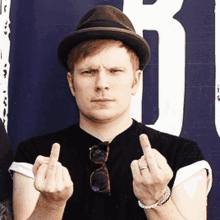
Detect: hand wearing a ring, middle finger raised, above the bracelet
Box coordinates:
(131, 134, 173, 205)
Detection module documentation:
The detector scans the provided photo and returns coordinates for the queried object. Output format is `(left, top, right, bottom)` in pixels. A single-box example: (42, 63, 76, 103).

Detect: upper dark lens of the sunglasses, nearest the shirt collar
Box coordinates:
(91, 145, 107, 163)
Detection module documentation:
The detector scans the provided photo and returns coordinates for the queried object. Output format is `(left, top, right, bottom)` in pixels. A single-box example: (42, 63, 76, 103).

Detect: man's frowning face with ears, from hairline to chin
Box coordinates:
(67, 43, 141, 122)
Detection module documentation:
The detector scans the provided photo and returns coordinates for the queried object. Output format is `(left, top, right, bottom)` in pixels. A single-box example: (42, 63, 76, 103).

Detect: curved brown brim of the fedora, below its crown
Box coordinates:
(58, 27, 150, 71)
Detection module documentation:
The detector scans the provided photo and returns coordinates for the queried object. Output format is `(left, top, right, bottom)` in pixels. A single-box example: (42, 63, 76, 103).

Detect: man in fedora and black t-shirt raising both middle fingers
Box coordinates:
(10, 6, 211, 220)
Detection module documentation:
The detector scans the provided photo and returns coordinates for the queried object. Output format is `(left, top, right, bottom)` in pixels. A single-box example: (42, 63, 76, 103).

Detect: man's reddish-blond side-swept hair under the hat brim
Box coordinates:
(67, 39, 139, 73)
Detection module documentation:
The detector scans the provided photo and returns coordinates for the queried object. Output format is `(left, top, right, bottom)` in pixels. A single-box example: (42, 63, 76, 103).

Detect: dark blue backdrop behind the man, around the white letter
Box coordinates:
(8, 0, 217, 220)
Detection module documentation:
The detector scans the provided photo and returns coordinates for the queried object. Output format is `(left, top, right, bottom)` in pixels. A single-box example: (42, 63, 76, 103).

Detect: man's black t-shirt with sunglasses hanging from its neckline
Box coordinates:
(14, 120, 204, 220)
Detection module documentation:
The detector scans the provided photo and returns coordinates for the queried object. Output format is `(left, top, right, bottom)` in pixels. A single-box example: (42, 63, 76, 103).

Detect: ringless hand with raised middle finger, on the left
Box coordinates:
(32, 143, 73, 205)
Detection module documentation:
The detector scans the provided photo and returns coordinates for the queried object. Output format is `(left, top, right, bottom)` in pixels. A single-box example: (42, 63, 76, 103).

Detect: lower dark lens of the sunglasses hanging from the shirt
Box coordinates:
(91, 170, 108, 192)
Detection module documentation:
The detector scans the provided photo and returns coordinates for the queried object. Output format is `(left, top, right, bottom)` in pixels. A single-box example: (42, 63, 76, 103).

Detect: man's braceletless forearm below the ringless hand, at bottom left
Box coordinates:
(27, 196, 66, 220)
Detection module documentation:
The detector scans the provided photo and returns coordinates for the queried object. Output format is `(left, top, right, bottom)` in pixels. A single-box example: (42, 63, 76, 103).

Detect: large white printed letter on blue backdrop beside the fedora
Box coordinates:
(123, 0, 185, 135)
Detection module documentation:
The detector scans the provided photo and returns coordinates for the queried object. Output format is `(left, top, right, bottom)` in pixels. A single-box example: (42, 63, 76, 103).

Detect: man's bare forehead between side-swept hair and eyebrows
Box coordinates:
(75, 45, 131, 68)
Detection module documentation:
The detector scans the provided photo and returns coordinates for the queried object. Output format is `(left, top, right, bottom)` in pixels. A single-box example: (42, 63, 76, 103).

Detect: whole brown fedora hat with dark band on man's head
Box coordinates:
(58, 5, 150, 71)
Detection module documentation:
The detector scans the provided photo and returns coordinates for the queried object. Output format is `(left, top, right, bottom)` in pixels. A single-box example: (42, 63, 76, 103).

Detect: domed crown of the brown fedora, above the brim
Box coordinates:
(76, 5, 135, 32)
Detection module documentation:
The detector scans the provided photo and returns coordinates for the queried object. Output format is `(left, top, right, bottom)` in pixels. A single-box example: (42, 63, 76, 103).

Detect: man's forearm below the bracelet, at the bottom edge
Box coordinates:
(144, 198, 186, 220)
